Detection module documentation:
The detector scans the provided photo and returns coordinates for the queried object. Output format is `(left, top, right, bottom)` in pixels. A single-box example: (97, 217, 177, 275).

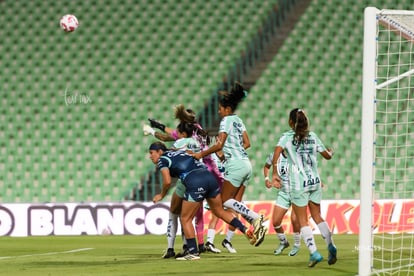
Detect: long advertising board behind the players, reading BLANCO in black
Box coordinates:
(0, 199, 414, 236)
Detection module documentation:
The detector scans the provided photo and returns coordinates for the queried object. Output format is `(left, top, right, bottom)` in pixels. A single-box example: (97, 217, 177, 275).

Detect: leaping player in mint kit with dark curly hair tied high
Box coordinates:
(193, 82, 267, 248)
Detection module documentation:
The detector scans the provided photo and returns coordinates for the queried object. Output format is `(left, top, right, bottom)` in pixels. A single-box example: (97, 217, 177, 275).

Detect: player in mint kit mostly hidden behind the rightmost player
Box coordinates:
(263, 152, 300, 256)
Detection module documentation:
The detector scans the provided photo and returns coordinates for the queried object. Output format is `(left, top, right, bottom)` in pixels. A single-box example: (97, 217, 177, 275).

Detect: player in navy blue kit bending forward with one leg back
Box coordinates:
(149, 142, 257, 260)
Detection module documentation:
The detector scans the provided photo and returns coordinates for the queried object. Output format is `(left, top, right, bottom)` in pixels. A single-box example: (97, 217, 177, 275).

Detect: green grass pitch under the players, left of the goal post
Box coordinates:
(0, 235, 358, 276)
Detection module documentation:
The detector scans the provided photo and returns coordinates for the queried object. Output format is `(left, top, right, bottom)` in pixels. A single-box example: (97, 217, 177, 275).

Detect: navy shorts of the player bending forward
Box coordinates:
(183, 169, 220, 202)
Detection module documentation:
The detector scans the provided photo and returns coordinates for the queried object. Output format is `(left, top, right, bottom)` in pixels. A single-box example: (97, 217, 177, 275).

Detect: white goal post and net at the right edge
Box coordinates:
(358, 7, 414, 275)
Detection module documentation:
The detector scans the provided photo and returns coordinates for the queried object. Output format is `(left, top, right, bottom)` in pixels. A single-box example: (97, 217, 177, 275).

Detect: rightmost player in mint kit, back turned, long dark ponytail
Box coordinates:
(272, 108, 336, 267)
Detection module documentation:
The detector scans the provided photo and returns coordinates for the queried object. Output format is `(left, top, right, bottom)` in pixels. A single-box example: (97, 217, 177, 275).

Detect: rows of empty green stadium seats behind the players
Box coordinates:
(0, 0, 410, 202)
